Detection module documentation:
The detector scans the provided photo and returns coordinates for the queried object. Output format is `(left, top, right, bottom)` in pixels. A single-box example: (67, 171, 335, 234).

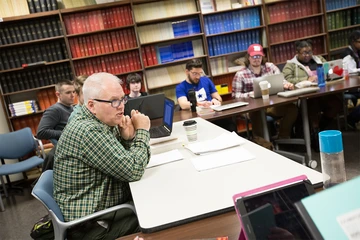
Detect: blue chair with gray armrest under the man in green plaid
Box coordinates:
(31, 170, 136, 240)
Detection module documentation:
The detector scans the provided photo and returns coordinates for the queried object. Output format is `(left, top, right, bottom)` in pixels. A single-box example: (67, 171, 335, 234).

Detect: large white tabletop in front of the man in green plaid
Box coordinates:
(130, 118, 322, 233)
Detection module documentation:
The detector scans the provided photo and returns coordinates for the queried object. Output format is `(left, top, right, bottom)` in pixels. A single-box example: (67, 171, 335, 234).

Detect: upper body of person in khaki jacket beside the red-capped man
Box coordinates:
(282, 40, 326, 84)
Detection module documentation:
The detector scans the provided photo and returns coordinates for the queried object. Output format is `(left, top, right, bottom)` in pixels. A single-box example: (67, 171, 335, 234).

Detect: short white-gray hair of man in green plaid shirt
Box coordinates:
(83, 72, 122, 103)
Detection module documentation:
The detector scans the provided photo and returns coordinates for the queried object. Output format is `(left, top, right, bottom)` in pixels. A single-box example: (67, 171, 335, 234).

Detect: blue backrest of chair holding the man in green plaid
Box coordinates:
(31, 170, 64, 222)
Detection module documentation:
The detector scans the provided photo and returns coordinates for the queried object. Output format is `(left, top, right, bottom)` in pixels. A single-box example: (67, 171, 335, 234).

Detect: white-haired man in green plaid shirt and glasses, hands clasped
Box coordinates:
(54, 73, 150, 239)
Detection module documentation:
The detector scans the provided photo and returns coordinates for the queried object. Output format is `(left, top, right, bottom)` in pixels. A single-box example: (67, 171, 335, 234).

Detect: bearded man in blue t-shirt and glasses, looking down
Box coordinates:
(176, 59, 222, 110)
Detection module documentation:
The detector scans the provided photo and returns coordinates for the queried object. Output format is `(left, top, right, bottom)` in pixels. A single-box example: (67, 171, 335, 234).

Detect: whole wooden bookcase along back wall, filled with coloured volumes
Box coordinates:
(0, 0, 360, 132)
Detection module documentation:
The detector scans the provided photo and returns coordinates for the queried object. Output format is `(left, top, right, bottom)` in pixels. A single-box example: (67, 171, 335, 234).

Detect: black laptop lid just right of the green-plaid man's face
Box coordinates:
(124, 93, 165, 120)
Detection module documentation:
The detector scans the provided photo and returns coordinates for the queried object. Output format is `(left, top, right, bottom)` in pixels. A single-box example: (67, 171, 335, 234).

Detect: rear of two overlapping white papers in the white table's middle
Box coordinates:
(185, 132, 245, 154)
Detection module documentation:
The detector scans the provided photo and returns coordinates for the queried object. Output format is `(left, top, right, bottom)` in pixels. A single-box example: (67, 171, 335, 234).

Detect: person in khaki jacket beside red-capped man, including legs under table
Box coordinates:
(282, 40, 342, 151)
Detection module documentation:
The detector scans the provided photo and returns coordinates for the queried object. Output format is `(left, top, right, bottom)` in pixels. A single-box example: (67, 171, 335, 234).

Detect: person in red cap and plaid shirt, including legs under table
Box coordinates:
(232, 44, 298, 138)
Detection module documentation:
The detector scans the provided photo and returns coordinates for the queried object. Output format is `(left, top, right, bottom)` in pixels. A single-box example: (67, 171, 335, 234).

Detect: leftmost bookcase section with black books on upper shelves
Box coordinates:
(0, 11, 73, 135)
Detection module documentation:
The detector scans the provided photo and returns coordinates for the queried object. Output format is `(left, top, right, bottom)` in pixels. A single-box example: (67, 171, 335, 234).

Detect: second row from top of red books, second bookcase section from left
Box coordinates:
(69, 28, 137, 58)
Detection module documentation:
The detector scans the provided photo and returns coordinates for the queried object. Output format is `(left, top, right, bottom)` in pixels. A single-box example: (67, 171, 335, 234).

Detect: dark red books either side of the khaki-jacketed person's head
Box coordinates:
(271, 37, 324, 64)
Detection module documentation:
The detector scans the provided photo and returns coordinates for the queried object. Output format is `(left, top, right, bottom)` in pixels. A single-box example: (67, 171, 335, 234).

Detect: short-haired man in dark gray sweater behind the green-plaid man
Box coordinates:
(36, 80, 75, 144)
